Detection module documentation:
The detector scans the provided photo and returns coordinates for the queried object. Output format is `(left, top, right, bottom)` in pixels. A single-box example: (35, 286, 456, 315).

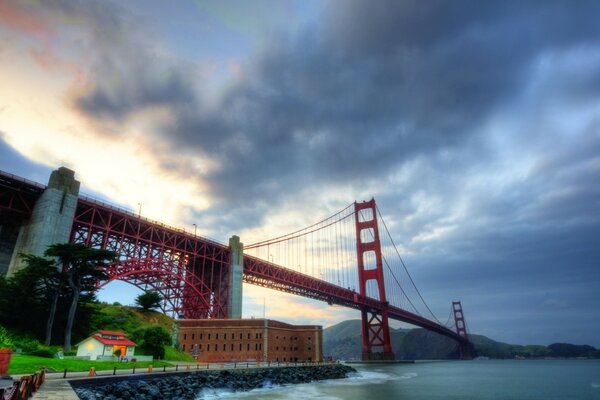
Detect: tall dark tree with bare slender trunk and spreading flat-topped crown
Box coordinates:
(44, 243, 116, 351)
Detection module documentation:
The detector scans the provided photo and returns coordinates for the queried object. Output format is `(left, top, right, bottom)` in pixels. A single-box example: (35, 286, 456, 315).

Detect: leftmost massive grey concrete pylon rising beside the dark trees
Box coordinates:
(8, 167, 79, 275)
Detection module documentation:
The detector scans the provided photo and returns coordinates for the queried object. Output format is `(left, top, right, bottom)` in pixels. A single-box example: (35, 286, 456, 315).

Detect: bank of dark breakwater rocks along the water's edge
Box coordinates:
(71, 364, 356, 400)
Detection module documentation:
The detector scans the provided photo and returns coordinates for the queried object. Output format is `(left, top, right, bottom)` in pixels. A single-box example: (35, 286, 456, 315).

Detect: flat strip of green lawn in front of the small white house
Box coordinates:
(8, 354, 172, 374)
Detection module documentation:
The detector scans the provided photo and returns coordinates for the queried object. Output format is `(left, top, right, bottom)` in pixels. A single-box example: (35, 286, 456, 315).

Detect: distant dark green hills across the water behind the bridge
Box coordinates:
(323, 320, 600, 360)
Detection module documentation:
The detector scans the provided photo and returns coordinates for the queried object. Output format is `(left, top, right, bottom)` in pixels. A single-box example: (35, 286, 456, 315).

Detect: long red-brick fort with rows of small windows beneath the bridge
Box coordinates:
(178, 319, 323, 362)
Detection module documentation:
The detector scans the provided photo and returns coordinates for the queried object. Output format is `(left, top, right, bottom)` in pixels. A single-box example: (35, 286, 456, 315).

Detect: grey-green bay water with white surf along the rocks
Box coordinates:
(198, 360, 600, 400)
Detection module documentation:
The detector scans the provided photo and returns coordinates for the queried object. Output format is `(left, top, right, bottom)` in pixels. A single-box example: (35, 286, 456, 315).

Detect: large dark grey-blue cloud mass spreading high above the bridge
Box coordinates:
(67, 2, 599, 231)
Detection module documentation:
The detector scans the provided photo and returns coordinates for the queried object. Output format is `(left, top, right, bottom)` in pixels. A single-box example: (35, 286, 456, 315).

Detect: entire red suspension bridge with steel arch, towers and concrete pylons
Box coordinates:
(0, 168, 472, 359)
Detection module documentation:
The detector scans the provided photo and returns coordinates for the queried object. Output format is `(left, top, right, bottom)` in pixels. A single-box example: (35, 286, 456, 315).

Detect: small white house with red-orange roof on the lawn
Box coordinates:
(77, 330, 135, 360)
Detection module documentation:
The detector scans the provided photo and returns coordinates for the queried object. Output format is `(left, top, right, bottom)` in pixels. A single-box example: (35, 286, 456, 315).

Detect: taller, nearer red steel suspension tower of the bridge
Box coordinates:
(354, 199, 395, 361)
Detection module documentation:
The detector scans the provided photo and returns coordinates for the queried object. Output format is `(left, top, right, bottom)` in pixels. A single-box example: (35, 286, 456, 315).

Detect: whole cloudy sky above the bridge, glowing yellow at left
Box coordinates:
(0, 0, 600, 347)
